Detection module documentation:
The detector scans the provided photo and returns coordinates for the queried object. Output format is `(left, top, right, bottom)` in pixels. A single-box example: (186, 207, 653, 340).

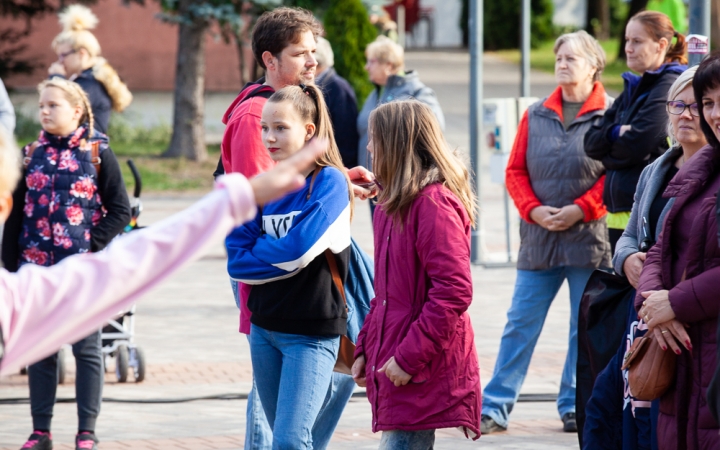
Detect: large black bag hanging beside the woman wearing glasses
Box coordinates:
(575, 270, 635, 448)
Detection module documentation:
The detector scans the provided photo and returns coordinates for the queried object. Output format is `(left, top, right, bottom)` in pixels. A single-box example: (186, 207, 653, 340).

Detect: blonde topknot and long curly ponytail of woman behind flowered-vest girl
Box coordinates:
(51, 5, 132, 112)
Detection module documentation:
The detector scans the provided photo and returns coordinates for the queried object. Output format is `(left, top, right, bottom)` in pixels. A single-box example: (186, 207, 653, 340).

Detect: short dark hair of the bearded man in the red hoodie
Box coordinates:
(252, 7, 323, 69)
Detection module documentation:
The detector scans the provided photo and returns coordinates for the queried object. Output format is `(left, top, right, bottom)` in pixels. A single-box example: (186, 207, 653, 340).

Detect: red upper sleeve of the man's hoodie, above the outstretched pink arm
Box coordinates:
(222, 106, 275, 178)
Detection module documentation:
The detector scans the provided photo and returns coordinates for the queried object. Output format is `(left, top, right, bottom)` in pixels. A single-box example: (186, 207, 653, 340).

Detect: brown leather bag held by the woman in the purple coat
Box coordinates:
(622, 331, 677, 401)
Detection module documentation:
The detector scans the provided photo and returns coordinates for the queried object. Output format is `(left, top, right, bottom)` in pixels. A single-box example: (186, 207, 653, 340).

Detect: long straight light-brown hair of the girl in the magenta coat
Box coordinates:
(370, 100, 476, 226)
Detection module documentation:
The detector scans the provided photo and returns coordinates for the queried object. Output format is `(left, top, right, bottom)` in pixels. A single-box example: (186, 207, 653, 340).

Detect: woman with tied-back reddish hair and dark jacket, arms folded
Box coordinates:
(585, 11, 687, 253)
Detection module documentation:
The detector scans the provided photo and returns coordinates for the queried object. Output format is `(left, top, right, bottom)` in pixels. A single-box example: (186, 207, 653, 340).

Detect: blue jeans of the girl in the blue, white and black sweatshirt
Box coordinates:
(250, 325, 340, 450)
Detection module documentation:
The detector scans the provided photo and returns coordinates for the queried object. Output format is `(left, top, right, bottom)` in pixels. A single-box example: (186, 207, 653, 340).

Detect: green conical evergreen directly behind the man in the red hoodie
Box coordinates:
(324, 0, 377, 104)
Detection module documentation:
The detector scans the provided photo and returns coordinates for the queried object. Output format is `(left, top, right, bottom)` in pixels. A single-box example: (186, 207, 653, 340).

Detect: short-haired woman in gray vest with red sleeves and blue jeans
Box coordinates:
(481, 31, 612, 434)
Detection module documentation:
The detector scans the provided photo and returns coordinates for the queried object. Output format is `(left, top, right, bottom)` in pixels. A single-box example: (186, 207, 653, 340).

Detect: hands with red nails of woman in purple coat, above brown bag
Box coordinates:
(638, 290, 692, 355)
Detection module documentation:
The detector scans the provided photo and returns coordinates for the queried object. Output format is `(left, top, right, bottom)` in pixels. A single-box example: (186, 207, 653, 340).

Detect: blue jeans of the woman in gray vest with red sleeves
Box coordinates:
(482, 267, 593, 428)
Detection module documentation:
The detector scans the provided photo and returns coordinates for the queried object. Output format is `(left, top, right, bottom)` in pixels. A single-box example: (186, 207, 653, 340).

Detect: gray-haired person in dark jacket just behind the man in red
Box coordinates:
(315, 38, 360, 167)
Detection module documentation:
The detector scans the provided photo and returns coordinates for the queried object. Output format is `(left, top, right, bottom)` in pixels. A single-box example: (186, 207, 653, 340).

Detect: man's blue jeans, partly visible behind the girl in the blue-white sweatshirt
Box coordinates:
(244, 335, 355, 450)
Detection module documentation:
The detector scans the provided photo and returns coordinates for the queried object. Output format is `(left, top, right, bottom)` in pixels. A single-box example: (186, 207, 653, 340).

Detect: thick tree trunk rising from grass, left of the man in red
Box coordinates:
(163, 0, 208, 161)
